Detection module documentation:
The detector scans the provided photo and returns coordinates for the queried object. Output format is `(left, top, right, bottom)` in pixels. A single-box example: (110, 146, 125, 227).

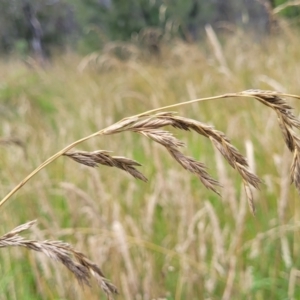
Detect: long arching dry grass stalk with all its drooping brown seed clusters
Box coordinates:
(0, 90, 300, 214)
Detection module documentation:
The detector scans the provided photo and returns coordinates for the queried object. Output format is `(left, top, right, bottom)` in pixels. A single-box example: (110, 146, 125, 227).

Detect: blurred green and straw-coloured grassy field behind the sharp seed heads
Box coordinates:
(0, 34, 300, 300)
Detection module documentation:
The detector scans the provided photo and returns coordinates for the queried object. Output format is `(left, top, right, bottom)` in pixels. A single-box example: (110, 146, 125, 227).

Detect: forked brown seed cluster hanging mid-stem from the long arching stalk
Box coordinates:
(95, 112, 261, 213)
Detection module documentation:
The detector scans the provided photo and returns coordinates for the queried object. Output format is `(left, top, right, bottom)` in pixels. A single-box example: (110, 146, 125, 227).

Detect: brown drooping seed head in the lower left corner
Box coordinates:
(0, 221, 118, 299)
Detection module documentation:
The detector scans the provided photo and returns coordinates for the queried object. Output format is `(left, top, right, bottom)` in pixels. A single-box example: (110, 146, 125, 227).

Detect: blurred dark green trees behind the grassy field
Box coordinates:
(0, 0, 300, 56)
